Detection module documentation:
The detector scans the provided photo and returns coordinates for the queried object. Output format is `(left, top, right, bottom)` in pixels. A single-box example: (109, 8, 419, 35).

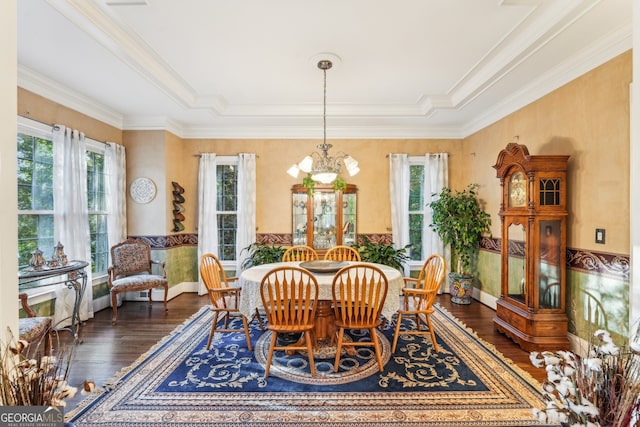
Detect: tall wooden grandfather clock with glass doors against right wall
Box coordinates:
(493, 143, 569, 351)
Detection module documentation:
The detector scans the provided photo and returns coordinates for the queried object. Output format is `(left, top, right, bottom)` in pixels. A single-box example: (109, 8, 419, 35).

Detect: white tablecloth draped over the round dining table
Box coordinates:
(239, 262, 404, 319)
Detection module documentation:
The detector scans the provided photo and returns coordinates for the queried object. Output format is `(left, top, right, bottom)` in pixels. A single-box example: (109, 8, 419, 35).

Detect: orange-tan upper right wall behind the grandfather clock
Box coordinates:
(462, 51, 631, 254)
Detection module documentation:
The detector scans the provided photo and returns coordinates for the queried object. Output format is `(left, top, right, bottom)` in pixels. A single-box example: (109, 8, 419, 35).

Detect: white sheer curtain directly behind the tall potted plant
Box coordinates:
(422, 153, 451, 287)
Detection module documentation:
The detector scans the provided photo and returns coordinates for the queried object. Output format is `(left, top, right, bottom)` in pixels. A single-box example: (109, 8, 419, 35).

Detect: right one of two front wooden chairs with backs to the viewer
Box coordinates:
(332, 264, 389, 372)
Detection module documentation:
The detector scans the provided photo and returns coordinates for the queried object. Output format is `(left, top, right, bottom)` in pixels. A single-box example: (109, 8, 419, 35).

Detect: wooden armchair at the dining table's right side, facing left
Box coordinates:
(391, 254, 446, 353)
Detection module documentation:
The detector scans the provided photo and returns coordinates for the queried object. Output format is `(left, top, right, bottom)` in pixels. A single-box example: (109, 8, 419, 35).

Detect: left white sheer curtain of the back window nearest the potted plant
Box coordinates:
(389, 154, 410, 276)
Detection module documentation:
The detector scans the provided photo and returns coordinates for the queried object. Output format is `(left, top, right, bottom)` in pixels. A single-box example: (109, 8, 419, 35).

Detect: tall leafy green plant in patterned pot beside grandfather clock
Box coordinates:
(429, 184, 491, 304)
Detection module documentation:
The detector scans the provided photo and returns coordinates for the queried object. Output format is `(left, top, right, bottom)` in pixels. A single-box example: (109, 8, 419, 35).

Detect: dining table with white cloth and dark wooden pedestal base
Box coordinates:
(238, 261, 404, 341)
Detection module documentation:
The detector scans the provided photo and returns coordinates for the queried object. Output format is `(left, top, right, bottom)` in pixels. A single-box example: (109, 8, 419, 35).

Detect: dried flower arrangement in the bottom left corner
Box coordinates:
(0, 329, 77, 406)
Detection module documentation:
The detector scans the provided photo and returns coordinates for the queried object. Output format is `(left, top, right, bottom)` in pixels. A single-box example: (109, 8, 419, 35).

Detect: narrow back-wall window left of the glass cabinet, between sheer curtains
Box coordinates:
(216, 156, 238, 261)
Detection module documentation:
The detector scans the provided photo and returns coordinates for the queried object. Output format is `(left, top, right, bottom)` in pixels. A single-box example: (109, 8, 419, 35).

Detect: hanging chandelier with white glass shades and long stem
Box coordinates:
(287, 59, 360, 184)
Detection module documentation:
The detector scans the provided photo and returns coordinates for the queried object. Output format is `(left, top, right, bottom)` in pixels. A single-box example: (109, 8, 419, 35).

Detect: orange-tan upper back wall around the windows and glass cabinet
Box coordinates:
(182, 139, 462, 233)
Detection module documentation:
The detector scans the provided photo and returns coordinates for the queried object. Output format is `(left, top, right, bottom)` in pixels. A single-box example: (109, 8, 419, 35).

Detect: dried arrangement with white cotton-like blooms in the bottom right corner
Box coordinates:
(529, 330, 640, 427)
